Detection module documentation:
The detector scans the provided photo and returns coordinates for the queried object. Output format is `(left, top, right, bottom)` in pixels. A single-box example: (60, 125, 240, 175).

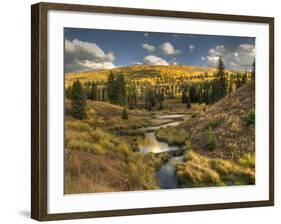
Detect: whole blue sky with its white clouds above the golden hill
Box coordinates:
(64, 28, 255, 73)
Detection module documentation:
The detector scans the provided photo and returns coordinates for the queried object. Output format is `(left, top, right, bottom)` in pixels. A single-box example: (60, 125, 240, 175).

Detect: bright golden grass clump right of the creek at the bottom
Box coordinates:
(176, 150, 255, 187)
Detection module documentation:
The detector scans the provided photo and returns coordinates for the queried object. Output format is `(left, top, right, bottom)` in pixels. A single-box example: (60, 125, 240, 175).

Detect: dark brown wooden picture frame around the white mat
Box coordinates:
(31, 3, 274, 221)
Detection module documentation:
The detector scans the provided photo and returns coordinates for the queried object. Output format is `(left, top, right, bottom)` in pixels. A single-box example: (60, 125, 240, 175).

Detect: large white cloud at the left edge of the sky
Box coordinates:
(65, 39, 116, 72)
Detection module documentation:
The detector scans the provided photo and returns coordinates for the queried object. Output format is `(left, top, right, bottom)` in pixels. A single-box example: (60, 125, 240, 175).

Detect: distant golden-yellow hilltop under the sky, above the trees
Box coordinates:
(65, 65, 233, 86)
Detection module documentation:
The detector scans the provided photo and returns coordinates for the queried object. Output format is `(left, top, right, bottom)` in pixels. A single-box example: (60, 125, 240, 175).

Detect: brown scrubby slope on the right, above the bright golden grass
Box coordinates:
(182, 81, 255, 159)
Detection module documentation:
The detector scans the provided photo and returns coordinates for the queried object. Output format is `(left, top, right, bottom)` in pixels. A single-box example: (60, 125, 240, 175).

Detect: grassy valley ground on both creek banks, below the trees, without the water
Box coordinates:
(65, 83, 255, 194)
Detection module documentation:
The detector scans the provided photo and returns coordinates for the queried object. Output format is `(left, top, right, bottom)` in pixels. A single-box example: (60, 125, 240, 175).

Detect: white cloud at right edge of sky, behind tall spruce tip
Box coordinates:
(201, 44, 255, 70)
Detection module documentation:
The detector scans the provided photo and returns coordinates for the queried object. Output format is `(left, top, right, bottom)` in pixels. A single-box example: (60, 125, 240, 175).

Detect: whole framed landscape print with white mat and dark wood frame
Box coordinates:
(31, 3, 274, 221)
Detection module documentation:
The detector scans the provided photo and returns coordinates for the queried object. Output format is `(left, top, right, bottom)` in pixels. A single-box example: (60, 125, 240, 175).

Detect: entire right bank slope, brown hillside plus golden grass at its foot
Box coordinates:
(176, 81, 255, 187)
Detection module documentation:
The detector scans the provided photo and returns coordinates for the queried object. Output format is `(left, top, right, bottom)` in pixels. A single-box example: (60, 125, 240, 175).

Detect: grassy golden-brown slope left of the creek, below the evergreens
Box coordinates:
(65, 99, 171, 194)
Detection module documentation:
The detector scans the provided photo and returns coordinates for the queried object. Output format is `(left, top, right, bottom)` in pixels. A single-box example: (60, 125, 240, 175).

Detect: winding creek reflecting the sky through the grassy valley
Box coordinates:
(139, 114, 189, 189)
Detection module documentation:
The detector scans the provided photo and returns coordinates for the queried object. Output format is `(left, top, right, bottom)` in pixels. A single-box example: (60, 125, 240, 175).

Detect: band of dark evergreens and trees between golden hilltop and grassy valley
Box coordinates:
(65, 58, 255, 119)
